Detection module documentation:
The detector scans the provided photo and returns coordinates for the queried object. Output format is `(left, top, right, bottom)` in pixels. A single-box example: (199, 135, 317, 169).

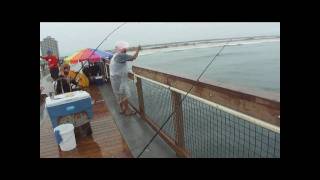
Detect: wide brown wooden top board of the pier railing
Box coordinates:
(131, 66, 280, 126)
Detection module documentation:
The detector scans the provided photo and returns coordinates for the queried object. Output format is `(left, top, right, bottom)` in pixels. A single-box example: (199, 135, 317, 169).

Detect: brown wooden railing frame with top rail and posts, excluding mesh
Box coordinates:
(110, 66, 280, 157)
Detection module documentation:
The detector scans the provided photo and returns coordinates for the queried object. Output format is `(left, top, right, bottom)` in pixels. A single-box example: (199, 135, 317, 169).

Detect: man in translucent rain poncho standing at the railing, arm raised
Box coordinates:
(110, 41, 141, 116)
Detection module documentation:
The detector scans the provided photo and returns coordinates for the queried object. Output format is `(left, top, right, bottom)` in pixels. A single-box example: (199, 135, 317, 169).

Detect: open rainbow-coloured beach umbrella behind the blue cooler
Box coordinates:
(64, 48, 113, 64)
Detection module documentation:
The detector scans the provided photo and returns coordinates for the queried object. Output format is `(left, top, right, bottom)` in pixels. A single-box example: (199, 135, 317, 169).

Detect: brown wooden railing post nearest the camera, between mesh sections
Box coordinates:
(171, 91, 185, 157)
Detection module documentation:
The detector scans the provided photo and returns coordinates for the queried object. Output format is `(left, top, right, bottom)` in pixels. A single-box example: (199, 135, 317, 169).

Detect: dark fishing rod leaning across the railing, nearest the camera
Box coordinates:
(137, 39, 232, 158)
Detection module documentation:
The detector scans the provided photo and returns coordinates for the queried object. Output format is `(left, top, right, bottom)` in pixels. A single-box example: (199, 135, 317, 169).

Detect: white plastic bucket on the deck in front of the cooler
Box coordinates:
(54, 124, 77, 151)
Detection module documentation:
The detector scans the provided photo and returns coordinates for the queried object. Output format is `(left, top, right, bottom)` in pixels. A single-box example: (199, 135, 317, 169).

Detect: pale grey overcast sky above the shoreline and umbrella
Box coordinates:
(40, 23, 280, 56)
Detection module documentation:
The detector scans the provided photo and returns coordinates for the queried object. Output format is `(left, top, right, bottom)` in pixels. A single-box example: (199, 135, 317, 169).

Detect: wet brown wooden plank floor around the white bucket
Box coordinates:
(40, 86, 132, 158)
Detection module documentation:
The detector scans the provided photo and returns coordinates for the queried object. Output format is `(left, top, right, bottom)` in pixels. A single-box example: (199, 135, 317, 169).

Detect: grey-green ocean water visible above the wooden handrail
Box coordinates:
(130, 41, 280, 99)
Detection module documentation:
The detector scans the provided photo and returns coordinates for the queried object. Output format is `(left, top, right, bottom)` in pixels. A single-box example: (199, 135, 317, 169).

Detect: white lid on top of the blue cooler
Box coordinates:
(46, 91, 91, 107)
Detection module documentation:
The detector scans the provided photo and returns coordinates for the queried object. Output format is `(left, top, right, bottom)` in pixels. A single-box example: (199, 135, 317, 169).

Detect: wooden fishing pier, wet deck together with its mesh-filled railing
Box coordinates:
(40, 63, 280, 158)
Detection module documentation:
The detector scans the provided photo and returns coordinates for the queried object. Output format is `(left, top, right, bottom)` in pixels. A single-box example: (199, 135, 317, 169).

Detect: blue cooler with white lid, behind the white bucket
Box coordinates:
(46, 91, 93, 128)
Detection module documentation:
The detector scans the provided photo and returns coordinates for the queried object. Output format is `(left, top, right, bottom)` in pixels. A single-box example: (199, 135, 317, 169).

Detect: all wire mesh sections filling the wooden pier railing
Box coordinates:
(129, 76, 280, 158)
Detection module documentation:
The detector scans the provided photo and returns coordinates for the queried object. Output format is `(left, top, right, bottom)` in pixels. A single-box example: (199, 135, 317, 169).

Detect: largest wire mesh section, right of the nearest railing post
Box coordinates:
(183, 94, 280, 158)
